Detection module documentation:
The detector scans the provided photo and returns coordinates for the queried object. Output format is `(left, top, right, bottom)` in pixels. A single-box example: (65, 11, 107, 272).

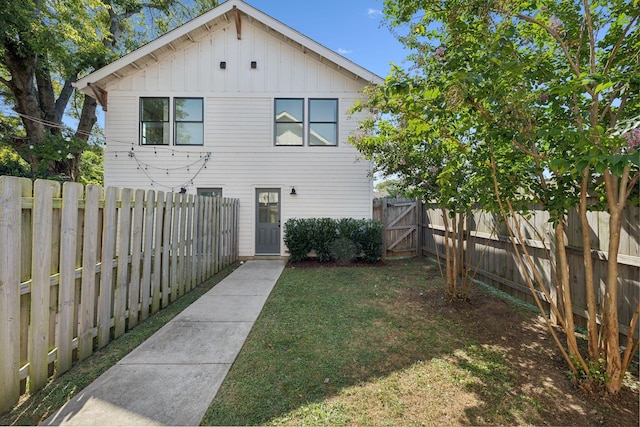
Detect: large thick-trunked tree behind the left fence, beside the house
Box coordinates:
(0, 0, 217, 180)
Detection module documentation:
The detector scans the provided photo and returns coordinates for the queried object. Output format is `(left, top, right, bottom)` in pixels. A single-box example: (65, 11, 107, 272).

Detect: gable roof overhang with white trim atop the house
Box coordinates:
(73, 0, 384, 106)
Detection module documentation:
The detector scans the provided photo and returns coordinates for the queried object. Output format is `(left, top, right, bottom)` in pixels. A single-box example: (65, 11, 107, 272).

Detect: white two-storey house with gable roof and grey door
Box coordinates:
(75, 0, 382, 258)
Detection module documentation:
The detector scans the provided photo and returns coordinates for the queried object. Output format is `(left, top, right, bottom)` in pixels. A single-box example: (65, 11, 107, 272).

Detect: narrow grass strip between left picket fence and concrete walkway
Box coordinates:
(0, 264, 238, 425)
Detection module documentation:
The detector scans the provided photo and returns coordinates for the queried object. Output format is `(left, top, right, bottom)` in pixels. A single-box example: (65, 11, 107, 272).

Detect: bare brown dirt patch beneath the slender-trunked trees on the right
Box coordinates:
(402, 287, 640, 426)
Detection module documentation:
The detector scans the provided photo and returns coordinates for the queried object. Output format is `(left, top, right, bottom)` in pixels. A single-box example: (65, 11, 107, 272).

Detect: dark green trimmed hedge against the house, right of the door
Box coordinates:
(284, 218, 382, 262)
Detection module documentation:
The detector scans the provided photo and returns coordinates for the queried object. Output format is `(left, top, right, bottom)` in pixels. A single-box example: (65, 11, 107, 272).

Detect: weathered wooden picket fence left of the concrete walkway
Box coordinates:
(0, 176, 238, 412)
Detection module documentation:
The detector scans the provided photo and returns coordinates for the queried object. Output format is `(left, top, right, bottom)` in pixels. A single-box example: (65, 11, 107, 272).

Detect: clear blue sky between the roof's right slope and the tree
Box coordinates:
(238, 0, 408, 78)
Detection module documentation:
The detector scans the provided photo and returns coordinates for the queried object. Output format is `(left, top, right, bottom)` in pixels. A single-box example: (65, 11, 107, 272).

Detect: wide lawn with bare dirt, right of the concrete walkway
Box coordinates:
(202, 259, 638, 426)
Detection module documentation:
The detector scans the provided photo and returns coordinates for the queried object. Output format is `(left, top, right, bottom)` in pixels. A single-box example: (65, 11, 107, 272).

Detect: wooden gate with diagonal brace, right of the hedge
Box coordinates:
(373, 199, 423, 259)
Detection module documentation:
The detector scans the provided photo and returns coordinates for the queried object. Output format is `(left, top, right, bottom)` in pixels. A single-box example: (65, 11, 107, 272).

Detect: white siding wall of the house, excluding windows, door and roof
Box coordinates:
(105, 15, 373, 257)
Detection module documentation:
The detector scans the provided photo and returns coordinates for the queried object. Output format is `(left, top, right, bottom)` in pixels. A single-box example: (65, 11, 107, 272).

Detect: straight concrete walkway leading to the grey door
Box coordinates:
(43, 261, 285, 426)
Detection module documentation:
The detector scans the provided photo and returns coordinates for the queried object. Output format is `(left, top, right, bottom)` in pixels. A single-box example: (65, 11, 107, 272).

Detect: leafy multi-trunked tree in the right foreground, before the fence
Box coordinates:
(355, 0, 640, 393)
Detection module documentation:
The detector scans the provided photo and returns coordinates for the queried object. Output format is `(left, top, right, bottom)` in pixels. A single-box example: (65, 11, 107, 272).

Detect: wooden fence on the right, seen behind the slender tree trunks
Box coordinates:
(422, 202, 640, 336)
